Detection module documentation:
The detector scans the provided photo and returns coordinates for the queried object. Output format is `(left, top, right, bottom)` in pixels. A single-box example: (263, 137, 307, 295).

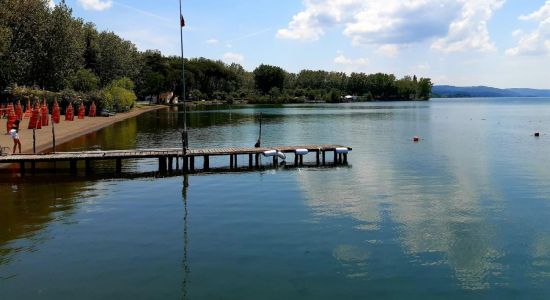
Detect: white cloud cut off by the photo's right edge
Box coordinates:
(506, 0, 550, 56)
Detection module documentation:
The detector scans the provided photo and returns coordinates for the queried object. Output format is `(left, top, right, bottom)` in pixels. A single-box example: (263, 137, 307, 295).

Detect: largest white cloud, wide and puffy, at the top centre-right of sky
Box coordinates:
(277, 0, 504, 52)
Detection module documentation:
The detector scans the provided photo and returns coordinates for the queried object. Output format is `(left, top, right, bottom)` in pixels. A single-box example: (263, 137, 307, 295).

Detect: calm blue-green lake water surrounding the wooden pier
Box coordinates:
(0, 99, 550, 299)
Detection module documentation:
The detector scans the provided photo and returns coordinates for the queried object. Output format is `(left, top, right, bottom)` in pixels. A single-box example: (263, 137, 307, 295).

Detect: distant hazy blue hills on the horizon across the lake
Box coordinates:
(432, 85, 550, 98)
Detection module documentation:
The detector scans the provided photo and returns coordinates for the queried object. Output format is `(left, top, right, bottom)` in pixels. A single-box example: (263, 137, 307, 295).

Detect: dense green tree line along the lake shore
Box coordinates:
(0, 0, 433, 111)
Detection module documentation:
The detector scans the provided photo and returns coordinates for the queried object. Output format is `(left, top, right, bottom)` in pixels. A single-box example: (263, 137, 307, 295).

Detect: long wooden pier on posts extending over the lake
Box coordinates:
(0, 145, 352, 174)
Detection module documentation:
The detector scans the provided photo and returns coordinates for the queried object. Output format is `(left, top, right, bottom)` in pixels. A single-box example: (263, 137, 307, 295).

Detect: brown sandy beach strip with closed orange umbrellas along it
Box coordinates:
(0, 105, 165, 154)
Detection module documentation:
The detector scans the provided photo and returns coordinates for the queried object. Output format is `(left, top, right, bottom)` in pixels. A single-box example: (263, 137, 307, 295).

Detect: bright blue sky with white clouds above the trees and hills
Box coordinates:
(53, 0, 550, 88)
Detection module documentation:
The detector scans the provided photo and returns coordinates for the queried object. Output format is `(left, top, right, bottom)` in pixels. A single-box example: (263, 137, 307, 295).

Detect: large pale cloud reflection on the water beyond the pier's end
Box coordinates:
(298, 113, 503, 290)
